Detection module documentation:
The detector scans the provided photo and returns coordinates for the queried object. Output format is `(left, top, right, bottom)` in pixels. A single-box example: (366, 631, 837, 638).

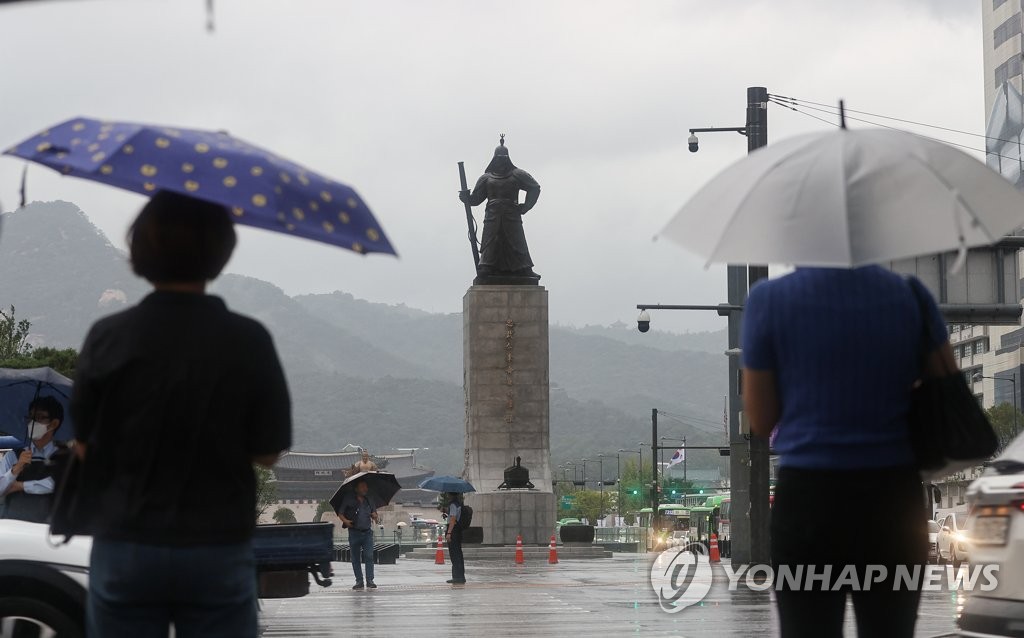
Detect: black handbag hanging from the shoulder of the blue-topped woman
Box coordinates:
(908, 278, 999, 479)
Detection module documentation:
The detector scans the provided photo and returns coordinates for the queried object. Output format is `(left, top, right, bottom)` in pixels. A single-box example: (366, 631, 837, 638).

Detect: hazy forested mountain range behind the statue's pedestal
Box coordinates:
(0, 202, 727, 476)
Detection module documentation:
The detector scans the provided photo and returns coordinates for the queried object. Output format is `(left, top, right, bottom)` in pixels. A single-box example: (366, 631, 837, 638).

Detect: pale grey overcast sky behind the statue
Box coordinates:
(0, 0, 984, 331)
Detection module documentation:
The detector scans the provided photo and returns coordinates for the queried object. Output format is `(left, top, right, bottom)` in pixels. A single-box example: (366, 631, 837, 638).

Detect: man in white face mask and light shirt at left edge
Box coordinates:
(0, 396, 67, 522)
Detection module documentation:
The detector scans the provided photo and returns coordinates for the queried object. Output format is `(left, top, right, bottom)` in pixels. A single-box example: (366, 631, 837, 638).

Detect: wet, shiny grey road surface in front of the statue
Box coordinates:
(260, 554, 957, 638)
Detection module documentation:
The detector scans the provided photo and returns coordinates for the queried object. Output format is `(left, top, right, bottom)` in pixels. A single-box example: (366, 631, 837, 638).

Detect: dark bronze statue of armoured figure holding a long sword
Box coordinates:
(459, 134, 541, 284)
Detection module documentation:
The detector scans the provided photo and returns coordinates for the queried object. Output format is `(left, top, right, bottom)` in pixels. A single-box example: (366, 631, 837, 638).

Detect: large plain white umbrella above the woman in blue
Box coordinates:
(660, 129, 1024, 267)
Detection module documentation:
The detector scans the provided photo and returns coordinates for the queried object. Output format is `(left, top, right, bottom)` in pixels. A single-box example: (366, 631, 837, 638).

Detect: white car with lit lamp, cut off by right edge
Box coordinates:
(959, 436, 1024, 638)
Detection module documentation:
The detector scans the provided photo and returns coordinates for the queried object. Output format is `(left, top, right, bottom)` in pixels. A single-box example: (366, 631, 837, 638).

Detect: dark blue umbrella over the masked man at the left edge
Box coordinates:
(0, 368, 75, 441)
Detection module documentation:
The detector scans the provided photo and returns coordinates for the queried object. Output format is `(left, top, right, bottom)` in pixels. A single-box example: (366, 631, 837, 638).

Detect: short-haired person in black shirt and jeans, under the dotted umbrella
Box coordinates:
(71, 192, 292, 638)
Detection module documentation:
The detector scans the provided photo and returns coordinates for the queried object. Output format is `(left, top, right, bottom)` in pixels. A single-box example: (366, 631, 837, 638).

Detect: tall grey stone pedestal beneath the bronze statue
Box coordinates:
(463, 286, 555, 545)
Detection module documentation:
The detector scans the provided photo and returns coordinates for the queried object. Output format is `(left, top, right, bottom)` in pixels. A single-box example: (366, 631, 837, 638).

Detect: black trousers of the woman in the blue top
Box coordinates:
(771, 468, 928, 638)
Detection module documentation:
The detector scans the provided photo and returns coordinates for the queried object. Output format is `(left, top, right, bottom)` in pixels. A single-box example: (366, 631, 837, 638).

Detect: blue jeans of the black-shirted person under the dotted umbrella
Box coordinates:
(87, 539, 257, 638)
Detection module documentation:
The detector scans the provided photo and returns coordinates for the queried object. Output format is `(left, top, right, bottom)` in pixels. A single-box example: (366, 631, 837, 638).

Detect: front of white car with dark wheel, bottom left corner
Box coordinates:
(0, 519, 92, 638)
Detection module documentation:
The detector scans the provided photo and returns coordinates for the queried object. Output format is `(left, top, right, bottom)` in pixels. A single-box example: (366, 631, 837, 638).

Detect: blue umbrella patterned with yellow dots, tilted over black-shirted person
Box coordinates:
(4, 118, 396, 255)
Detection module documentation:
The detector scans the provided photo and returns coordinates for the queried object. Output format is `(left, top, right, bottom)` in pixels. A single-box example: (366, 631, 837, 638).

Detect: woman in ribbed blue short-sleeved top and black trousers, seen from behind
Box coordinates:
(742, 266, 955, 638)
